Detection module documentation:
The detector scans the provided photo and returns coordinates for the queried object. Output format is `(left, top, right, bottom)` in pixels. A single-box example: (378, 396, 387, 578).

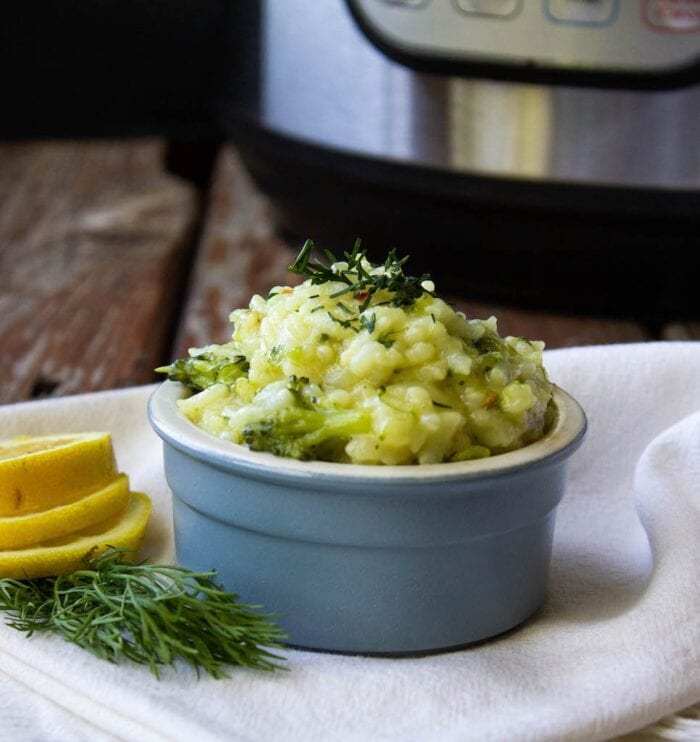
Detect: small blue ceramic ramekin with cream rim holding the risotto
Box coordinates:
(149, 381, 586, 654)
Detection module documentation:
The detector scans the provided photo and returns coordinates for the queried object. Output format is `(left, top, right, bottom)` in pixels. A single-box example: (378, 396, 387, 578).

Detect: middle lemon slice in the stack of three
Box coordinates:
(0, 474, 129, 549)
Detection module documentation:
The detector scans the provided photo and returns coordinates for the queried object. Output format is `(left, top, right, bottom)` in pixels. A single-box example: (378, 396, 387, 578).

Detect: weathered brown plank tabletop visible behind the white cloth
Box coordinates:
(0, 140, 700, 403)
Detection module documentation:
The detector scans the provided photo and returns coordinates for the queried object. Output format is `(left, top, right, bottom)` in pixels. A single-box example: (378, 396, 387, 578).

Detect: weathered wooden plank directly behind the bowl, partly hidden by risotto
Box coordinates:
(173, 147, 650, 357)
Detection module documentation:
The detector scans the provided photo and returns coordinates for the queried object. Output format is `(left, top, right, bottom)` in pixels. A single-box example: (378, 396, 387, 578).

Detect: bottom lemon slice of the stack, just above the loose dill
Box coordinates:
(0, 492, 151, 580)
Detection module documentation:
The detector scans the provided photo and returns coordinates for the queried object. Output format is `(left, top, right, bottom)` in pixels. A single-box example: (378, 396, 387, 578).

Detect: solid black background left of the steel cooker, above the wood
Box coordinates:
(0, 0, 232, 139)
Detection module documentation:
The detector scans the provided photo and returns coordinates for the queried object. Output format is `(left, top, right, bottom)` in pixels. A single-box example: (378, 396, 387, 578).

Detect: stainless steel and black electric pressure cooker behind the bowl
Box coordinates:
(227, 0, 700, 319)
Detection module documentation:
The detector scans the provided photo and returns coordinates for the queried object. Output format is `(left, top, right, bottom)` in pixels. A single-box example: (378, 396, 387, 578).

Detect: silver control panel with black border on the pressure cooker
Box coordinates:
(350, 0, 700, 78)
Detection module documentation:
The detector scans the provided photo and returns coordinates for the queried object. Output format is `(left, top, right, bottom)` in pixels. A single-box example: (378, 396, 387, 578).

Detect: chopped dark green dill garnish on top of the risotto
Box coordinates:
(289, 239, 434, 334)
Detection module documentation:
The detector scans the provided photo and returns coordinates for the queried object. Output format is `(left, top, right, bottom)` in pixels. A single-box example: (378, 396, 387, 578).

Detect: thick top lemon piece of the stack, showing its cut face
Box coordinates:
(0, 433, 117, 517)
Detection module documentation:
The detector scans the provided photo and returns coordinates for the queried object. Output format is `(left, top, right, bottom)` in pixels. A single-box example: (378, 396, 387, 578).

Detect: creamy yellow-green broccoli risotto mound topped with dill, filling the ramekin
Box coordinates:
(159, 242, 552, 464)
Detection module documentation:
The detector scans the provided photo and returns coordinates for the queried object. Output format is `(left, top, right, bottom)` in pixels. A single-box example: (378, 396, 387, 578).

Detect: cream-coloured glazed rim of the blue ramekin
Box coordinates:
(148, 381, 587, 485)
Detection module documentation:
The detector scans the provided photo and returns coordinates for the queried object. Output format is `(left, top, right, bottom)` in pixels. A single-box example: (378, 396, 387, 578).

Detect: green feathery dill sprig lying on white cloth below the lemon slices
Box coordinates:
(0, 548, 286, 678)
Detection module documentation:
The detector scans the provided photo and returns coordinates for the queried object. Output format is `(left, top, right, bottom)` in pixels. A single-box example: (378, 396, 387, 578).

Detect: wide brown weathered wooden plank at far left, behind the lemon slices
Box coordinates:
(0, 141, 198, 402)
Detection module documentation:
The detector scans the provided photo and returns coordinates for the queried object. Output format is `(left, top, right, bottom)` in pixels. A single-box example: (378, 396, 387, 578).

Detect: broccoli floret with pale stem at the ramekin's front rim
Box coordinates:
(243, 407, 371, 461)
